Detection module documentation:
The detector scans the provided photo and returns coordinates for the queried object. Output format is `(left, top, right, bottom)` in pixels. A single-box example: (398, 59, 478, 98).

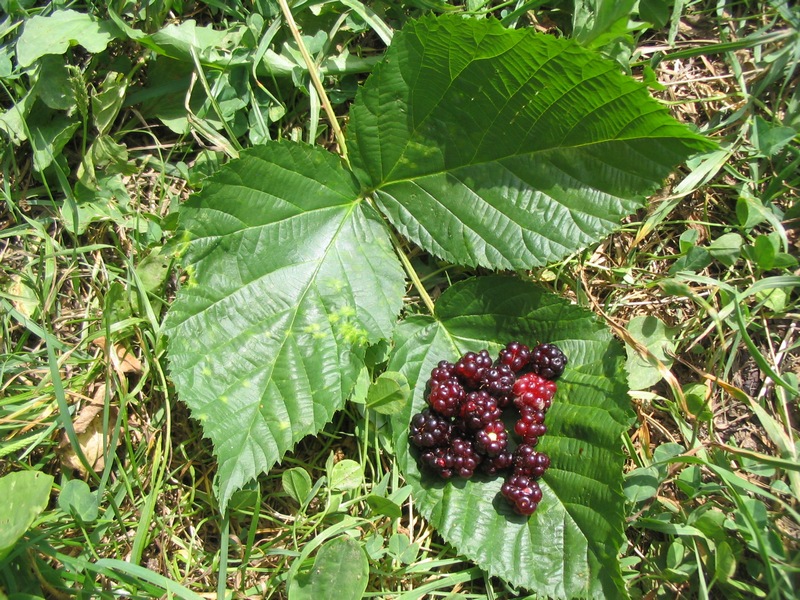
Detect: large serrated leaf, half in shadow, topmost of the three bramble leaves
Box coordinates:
(348, 16, 712, 268)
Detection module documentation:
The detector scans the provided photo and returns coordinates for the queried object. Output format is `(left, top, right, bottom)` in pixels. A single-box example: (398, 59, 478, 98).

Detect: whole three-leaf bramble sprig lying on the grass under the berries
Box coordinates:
(167, 16, 714, 597)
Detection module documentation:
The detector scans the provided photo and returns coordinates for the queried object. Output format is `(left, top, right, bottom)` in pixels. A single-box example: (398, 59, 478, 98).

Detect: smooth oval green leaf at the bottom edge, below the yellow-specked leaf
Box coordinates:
(288, 535, 369, 600)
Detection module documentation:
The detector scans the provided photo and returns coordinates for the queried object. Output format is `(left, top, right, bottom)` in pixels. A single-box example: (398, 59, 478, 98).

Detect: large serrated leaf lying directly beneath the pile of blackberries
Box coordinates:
(389, 276, 633, 598)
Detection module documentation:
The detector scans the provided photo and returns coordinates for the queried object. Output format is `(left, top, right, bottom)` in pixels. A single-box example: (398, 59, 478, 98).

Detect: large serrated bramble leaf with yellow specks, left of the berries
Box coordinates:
(166, 142, 404, 510)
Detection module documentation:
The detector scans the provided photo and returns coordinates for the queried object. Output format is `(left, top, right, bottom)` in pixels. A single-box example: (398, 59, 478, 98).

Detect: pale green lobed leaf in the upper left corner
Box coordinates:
(17, 10, 117, 67)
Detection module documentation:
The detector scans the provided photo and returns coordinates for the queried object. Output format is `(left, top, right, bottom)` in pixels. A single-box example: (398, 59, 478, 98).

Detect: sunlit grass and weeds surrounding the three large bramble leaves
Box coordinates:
(0, 1, 800, 598)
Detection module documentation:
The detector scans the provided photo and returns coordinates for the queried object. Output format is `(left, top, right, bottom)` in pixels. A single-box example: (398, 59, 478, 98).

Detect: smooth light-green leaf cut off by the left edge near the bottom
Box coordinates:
(0, 471, 53, 560)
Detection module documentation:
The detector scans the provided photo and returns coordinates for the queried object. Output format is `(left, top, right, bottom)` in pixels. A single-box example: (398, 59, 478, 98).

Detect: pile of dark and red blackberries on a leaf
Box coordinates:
(409, 342, 567, 515)
